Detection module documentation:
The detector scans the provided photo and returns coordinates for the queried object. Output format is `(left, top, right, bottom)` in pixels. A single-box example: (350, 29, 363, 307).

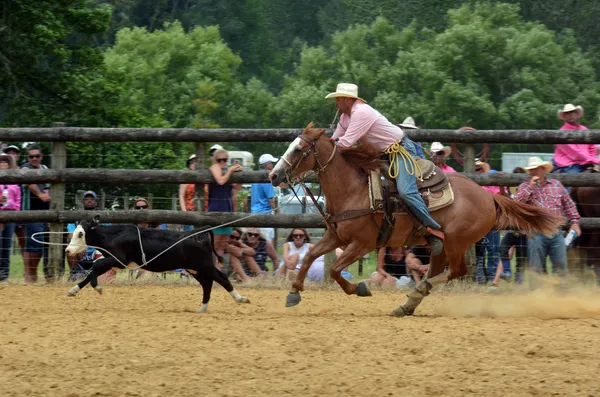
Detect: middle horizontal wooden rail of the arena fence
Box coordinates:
(0, 168, 600, 186)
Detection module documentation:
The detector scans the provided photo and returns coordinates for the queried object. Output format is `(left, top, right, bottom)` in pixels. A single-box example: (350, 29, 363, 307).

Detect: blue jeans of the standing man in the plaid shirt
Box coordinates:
(527, 232, 567, 275)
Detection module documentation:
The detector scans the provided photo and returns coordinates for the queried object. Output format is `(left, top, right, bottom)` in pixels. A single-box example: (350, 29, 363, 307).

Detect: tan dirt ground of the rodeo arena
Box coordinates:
(0, 285, 600, 397)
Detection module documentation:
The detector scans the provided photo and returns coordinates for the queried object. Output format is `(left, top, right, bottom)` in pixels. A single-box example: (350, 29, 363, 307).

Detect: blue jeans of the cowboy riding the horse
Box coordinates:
(396, 137, 440, 230)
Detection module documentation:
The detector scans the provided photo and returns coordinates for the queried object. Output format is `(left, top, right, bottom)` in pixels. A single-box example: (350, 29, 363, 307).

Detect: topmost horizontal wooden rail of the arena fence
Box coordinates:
(0, 127, 600, 144)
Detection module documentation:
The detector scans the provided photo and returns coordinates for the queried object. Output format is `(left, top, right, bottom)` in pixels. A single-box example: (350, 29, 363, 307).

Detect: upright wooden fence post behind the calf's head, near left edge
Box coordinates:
(48, 123, 67, 281)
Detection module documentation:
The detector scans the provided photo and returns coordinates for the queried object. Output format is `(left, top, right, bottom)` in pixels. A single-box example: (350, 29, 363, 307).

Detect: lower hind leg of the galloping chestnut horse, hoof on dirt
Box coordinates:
(390, 251, 450, 317)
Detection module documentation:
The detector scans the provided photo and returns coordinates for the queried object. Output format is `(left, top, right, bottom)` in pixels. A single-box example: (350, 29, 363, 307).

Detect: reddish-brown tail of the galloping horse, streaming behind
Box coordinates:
(493, 194, 564, 236)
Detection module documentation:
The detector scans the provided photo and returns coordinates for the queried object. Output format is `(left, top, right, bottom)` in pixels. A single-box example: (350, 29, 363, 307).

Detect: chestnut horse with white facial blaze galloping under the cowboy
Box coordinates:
(269, 123, 563, 316)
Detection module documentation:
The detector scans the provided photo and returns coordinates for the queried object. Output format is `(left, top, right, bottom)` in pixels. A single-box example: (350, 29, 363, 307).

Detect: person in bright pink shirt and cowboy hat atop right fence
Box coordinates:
(553, 103, 600, 174)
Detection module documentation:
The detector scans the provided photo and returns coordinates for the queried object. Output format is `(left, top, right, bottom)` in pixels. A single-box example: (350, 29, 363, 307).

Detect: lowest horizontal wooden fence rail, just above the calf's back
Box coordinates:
(0, 210, 600, 230)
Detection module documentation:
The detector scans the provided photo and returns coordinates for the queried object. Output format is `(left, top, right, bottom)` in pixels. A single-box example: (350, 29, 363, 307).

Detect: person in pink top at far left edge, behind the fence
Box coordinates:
(0, 154, 21, 282)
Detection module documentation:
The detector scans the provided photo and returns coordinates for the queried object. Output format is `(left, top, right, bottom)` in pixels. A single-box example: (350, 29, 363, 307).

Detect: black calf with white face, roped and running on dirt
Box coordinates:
(65, 216, 250, 313)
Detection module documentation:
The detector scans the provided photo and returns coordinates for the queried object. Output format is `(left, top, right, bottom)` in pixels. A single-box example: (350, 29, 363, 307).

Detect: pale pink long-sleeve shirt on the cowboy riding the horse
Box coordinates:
(332, 100, 404, 152)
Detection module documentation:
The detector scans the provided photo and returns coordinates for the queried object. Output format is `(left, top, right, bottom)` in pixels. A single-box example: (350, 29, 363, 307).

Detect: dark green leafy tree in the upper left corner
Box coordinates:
(0, 0, 119, 126)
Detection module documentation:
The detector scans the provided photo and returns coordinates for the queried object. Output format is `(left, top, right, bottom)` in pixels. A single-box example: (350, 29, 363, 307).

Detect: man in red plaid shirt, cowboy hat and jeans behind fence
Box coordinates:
(515, 157, 581, 275)
